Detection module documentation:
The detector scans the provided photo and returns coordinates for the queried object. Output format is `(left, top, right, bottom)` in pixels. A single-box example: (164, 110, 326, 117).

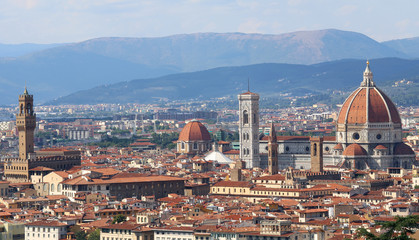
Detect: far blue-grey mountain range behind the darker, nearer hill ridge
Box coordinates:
(0, 29, 419, 104)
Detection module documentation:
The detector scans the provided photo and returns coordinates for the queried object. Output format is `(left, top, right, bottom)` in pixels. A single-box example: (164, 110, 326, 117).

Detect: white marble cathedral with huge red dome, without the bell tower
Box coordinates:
(254, 62, 415, 169)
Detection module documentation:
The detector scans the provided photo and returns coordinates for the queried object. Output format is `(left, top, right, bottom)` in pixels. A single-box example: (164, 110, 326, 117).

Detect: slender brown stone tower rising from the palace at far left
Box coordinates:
(16, 88, 36, 160)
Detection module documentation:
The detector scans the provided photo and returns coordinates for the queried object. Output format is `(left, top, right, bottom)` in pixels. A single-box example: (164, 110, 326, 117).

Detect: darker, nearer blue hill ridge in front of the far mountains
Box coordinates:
(49, 58, 419, 104)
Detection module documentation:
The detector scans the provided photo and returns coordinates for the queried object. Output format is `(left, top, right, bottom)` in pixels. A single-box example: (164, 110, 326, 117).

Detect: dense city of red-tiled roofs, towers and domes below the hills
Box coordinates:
(0, 63, 419, 240)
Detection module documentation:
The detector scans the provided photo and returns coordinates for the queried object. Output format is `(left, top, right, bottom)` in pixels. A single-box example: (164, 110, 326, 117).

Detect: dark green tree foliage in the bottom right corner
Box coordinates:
(356, 215, 419, 240)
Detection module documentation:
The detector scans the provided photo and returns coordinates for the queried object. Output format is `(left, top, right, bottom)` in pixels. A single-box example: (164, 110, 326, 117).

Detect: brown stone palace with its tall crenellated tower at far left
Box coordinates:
(4, 88, 81, 182)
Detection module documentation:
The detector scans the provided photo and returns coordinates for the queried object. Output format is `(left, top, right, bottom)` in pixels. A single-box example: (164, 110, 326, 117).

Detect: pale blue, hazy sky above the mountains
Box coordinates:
(0, 0, 419, 44)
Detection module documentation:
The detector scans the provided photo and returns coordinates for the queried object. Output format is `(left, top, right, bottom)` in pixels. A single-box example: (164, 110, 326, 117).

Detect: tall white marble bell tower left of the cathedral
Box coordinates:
(238, 91, 260, 168)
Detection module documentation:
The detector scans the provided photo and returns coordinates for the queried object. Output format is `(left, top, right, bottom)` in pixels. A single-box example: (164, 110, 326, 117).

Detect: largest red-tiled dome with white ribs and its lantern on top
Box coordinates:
(337, 63, 401, 124)
